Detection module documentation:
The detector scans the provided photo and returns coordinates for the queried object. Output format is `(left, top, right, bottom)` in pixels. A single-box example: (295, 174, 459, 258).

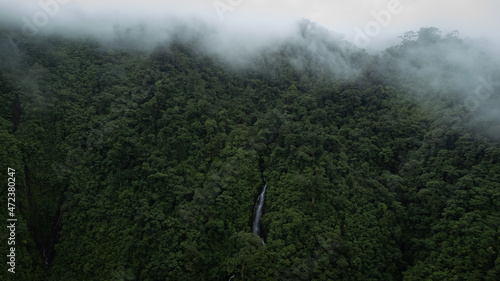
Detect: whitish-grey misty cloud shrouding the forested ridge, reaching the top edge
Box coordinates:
(0, 0, 500, 137)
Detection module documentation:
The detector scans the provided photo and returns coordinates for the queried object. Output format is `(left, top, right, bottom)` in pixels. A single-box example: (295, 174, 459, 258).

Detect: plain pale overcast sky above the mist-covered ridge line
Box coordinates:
(0, 0, 500, 49)
